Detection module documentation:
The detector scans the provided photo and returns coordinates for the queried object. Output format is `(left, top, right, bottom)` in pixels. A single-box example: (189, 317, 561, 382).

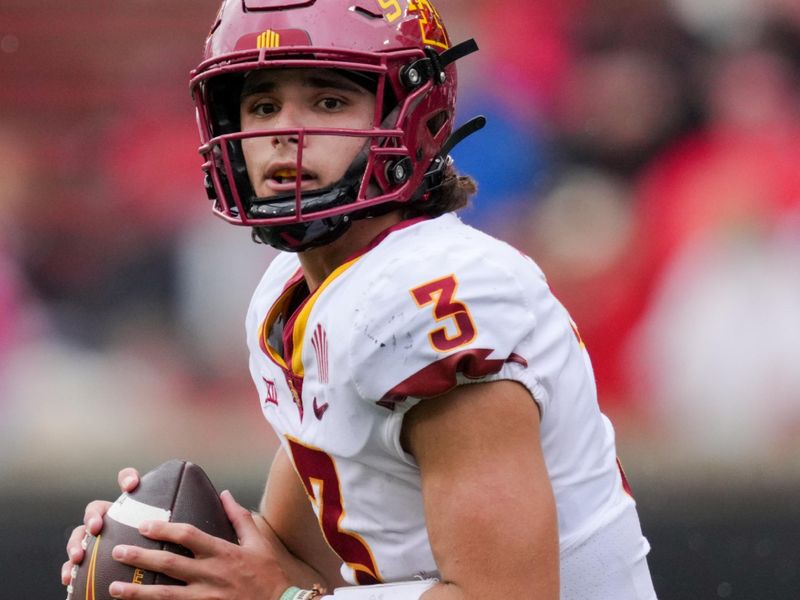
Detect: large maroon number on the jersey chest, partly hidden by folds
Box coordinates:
(286, 436, 381, 585)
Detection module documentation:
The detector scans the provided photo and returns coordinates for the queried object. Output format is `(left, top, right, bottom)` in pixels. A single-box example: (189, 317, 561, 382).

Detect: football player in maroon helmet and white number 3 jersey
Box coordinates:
(62, 0, 655, 600)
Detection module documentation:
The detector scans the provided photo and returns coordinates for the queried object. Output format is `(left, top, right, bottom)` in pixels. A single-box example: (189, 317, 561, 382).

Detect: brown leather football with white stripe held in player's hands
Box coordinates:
(67, 460, 237, 600)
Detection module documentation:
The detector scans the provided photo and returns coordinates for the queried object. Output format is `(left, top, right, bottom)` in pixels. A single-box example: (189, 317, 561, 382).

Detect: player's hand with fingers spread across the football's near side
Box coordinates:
(109, 491, 290, 600)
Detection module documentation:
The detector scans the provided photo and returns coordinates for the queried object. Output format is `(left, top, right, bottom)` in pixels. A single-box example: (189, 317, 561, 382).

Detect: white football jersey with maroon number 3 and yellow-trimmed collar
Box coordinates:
(247, 214, 655, 600)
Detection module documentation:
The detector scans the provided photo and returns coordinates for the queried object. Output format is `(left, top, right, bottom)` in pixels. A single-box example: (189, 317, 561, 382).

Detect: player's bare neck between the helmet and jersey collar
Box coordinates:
(298, 211, 401, 293)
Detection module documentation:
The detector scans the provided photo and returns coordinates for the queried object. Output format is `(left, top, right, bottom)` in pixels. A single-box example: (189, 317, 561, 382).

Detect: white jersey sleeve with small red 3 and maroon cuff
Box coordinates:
(350, 244, 547, 411)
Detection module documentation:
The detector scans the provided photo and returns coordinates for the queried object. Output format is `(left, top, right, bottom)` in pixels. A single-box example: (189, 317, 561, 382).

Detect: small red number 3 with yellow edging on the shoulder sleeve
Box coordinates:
(411, 275, 477, 352)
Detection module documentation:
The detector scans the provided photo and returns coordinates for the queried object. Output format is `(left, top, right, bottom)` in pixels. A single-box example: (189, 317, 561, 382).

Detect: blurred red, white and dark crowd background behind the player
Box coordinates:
(0, 0, 800, 600)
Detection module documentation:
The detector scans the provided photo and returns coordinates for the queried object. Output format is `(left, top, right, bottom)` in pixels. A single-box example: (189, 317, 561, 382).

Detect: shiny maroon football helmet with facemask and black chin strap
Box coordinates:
(191, 0, 483, 251)
